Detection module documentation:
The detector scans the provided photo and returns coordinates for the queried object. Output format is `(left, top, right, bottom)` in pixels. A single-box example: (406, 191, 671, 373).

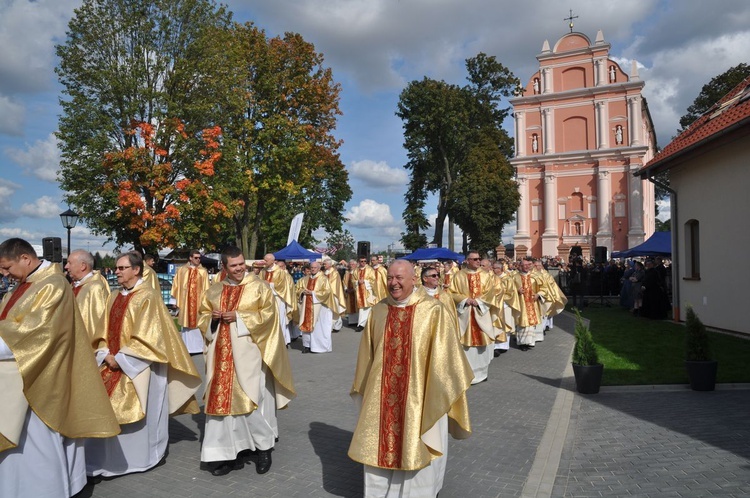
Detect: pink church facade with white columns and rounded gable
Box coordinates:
(510, 28, 656, 261)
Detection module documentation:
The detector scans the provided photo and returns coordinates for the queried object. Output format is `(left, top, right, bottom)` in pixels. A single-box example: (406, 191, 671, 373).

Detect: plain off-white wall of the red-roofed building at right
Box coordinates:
(670, 137, 750, 332)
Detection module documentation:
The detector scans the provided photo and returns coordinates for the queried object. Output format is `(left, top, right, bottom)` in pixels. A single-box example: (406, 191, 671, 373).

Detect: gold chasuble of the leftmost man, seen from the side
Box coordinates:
(0, 264, 120, 455)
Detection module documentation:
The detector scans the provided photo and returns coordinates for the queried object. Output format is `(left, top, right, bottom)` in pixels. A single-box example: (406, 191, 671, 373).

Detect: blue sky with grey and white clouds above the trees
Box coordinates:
(0, 0, 750, 255)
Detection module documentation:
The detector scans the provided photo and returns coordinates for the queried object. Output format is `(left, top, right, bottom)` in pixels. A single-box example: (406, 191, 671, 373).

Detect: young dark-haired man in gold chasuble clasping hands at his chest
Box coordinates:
(198, 247, 296, 476)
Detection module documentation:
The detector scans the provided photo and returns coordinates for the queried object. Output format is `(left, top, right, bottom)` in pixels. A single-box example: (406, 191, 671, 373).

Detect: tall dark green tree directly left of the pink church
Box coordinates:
(396, 53, 519, 253)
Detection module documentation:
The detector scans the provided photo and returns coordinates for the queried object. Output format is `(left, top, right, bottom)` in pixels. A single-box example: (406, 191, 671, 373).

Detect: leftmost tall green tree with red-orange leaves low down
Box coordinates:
(56, 0, 231, 252)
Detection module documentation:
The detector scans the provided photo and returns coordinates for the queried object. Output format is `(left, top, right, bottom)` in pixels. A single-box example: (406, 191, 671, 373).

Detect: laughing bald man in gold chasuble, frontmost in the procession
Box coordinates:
(349, 260, 472, 498)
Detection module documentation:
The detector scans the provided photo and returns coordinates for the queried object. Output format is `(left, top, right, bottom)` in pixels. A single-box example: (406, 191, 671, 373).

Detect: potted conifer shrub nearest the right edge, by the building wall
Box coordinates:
(685, 307, 719, 391)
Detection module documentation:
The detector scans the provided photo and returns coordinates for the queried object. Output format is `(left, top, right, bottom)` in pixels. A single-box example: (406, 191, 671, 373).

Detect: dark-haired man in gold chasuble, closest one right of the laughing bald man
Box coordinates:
(449, 251, 499, 384)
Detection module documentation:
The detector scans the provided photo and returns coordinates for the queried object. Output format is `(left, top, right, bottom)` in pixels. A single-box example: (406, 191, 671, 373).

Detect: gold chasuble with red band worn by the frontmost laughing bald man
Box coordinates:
(349, 287, 474, 470)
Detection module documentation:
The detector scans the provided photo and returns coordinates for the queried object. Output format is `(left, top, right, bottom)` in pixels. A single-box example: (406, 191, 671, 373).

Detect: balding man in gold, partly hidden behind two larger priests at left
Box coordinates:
(65, 249, 110, 340)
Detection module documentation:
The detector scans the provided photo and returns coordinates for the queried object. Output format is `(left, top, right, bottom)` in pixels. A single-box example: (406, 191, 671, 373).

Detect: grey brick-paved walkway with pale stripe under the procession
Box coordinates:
(80, 315, 750, 498)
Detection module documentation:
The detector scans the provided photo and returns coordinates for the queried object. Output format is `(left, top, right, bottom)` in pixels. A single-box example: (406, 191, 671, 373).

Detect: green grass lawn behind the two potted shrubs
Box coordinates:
(581, 305, 750, 386)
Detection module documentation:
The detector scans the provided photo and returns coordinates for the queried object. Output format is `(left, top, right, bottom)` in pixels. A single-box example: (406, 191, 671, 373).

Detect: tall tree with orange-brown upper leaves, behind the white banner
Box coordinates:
(194, 23, 351, 257)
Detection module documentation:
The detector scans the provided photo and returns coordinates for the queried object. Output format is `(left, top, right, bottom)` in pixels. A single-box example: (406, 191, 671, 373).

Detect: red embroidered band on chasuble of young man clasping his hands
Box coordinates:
(206, 285, 245, 415)
